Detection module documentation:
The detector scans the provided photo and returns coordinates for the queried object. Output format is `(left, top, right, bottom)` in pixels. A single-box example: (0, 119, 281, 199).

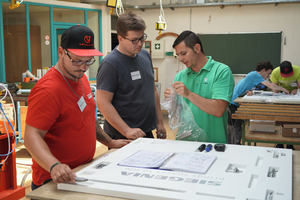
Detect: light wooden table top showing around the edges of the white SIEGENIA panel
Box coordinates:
(26, 143, 300, 200)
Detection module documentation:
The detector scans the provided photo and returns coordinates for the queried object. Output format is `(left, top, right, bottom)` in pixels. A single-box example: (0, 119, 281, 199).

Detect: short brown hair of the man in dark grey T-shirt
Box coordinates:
(117, 12, 147, 37)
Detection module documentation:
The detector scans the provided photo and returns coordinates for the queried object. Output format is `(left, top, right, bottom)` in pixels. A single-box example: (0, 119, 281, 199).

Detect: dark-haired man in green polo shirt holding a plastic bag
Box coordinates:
(164, 31, 234, 143)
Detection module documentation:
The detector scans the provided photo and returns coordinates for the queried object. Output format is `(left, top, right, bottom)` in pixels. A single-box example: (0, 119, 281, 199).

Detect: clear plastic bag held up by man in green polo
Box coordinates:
(161, 90, 209, 142)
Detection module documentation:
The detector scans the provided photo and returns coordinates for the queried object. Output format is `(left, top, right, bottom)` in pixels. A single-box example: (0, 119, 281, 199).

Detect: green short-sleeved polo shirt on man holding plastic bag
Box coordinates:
(174, 56, 234, 143)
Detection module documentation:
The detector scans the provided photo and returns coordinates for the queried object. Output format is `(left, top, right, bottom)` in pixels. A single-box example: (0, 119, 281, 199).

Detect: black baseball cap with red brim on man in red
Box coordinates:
(60, 24, 103, 56)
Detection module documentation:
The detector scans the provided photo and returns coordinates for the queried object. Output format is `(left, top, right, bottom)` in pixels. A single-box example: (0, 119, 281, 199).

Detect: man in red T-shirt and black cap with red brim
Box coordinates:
(24, 26, 128, 190)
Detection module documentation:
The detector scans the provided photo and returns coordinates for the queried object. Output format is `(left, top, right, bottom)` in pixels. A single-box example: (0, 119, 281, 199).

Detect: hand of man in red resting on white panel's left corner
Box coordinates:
(50, 164, 76, 183)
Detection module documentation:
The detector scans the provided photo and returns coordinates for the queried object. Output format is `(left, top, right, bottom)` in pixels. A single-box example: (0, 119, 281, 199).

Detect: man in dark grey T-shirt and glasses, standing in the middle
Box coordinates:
(97, 12, 166, 139)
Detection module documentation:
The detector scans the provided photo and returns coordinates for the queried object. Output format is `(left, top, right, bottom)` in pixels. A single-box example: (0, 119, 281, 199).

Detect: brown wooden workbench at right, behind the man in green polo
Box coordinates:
(232, 97, 300, 145)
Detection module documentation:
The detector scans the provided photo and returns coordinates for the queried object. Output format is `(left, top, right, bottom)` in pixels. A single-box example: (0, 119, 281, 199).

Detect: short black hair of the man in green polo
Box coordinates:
(173, 31, 204, 54)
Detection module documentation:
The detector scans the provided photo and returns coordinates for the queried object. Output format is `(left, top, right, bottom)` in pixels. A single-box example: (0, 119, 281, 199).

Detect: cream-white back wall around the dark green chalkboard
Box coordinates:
(127, 3, 300, 100)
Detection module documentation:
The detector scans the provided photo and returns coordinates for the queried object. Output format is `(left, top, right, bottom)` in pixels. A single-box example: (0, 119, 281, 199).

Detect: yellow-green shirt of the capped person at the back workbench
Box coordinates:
(270, 65, 300, 92)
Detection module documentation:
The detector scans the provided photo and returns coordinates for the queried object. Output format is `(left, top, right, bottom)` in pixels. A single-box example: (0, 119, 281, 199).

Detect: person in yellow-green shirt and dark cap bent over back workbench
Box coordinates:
(270, 60, 300, 150)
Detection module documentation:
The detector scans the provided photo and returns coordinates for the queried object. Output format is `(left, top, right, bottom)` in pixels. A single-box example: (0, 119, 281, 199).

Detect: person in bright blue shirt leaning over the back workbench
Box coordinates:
(228, 61, 289, 144)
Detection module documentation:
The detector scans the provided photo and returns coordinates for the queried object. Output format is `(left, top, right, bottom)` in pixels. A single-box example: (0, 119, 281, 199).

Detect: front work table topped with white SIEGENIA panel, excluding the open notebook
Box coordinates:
(26, 138, 300, 200)
